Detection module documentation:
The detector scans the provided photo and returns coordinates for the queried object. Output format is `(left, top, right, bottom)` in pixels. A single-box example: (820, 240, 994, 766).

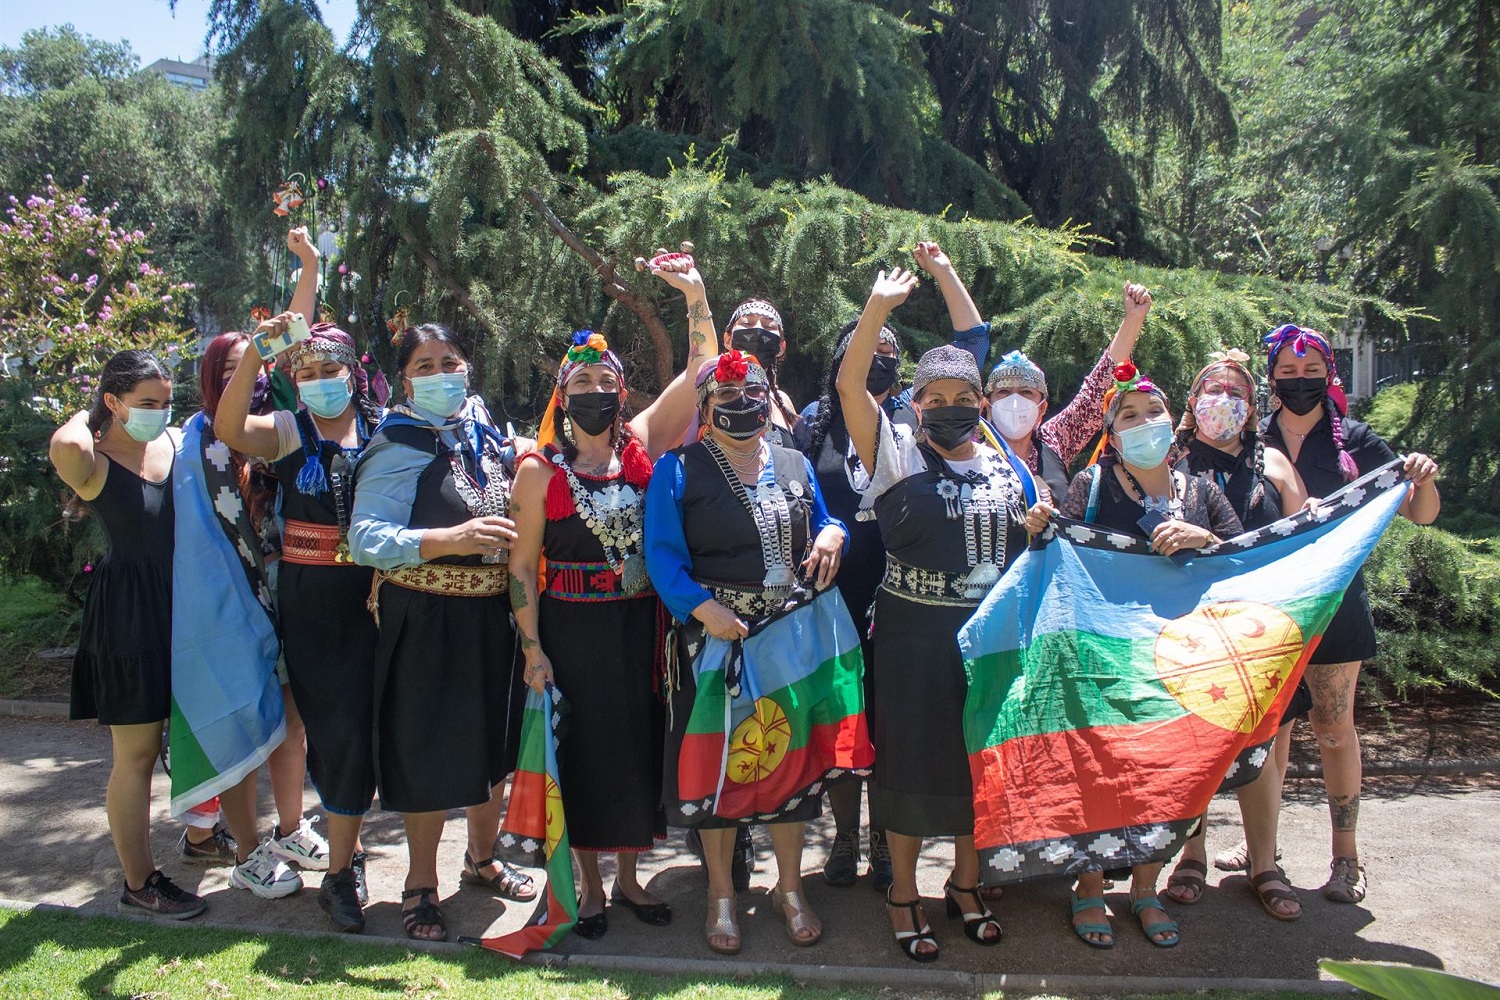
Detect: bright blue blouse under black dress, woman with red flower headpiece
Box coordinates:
(645, 451, 849, 622)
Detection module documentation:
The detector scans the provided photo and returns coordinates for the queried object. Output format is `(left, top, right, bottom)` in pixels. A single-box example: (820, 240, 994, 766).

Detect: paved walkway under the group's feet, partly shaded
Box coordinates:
(0, 718, 1500, 982)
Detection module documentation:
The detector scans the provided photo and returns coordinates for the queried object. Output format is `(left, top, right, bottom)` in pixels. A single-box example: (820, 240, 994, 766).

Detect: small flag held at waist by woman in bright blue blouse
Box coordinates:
(665, 588, 875, 826)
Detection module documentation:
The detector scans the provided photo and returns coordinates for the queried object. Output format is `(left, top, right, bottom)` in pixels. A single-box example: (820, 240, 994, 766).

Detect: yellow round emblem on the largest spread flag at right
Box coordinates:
(1155, 601, 1305, 733)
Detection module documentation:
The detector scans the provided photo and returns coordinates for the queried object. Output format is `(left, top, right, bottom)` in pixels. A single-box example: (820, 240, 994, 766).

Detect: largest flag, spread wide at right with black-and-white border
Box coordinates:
(959, 463, 1406, 885)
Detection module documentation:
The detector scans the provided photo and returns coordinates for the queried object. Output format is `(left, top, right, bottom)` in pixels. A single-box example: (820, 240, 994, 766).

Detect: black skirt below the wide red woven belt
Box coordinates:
(276, 559, 386, 816)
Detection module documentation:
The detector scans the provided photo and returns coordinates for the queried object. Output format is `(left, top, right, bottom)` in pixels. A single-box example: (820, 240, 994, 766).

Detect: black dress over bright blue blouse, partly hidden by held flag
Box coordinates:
(666, 443, 824, 829)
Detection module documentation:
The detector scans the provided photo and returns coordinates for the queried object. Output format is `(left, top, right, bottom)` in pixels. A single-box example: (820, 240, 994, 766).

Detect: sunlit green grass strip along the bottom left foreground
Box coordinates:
(0, 910, 1338, 1000)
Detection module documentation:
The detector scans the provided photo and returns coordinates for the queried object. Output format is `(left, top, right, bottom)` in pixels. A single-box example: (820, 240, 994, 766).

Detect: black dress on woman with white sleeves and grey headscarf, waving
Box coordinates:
(870, 425, 1028, 837)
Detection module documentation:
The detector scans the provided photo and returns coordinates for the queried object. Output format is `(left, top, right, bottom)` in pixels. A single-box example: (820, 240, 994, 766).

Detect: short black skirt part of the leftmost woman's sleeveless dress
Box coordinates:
(68, 552, 173, 726)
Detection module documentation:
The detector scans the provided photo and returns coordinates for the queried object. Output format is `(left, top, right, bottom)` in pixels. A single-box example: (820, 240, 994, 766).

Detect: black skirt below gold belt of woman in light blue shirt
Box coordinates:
(374, 582, 522, 813)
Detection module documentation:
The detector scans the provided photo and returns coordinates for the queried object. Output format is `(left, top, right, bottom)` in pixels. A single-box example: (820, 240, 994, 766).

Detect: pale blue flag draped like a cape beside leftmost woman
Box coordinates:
(168, 414, 287, 817)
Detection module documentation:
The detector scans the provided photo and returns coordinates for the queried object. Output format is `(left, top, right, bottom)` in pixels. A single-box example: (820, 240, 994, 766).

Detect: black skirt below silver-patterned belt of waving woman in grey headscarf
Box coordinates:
(870, 588, 974, 837)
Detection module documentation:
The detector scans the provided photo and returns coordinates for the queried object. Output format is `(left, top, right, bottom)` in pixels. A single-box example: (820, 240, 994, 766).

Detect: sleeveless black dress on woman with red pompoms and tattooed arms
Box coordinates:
(537, 444, 666, 852)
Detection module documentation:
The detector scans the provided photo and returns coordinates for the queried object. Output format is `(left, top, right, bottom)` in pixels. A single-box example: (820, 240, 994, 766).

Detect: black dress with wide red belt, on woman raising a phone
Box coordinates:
(273, 411, 378, 816)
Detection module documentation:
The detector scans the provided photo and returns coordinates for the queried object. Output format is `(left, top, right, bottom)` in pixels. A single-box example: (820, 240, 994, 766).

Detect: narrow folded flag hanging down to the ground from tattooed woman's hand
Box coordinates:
(468, 685, 578, 958)
